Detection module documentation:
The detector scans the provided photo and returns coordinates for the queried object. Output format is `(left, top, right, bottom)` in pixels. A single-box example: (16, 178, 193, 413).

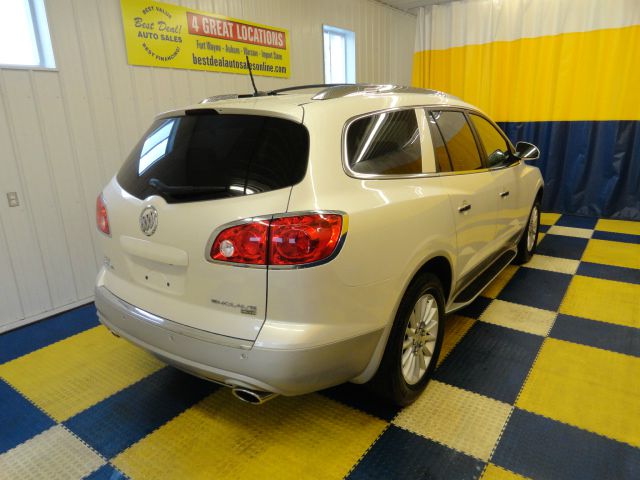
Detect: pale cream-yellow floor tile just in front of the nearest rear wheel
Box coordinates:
(393, 380, 512, 460)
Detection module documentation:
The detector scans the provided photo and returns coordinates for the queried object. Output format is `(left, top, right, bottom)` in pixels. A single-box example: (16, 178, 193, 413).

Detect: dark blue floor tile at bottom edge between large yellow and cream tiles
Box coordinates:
(347, 425, 485, 480)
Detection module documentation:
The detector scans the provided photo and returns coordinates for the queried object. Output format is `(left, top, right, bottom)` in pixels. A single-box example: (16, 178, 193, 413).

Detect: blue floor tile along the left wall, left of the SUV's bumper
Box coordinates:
(0, 303, 98, 363)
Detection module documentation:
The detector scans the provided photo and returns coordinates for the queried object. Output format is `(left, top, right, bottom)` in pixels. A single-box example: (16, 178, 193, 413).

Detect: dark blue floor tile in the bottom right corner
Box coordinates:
(491, 408, 640, 480)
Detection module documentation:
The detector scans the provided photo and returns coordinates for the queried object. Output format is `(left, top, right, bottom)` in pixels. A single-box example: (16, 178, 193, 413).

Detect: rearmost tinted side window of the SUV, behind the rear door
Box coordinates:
(347, 110, 422, 175)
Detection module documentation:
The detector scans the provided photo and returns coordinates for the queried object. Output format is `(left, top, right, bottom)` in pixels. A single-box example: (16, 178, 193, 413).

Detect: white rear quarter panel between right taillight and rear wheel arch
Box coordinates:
(256, 101, 456, 345)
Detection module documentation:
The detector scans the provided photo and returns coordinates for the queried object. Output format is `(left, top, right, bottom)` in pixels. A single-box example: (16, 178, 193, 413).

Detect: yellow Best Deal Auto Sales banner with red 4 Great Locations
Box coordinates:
(120, 0, 290, 78)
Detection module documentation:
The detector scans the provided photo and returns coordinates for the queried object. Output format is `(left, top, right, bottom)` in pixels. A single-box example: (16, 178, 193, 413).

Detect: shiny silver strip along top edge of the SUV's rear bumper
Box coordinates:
(95, 287, 253, 350)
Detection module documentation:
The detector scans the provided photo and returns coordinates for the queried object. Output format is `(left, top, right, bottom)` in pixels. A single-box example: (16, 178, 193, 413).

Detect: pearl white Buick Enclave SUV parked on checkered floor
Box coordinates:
(95, 85, 543, 405)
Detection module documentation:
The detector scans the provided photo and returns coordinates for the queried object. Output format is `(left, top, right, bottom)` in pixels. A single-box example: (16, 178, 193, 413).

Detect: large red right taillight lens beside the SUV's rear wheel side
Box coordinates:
(210, 213, 343, 266)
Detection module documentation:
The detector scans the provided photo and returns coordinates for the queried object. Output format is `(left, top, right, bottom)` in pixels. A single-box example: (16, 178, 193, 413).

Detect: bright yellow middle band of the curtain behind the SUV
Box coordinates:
(413, 25, 640, 122)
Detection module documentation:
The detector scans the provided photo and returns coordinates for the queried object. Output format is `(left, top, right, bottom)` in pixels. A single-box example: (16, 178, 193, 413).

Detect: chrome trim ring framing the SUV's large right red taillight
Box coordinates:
(204, 210, 349, 270)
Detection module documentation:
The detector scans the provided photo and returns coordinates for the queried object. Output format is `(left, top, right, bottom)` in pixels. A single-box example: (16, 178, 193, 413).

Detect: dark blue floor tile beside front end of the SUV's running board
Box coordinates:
(497, 266, 571, 311)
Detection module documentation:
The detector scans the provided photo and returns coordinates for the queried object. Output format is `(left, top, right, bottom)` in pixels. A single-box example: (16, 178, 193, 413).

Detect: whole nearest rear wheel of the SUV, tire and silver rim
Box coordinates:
(372, 273, 444, 406)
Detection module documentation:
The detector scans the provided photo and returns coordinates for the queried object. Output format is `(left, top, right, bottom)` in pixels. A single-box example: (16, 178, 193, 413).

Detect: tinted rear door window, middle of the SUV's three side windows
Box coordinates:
(432, 111, 482, 171)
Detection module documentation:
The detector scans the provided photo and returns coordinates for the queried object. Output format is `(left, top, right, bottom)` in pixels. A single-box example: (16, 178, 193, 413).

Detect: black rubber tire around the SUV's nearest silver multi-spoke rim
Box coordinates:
(370, 273, 445, 407)
